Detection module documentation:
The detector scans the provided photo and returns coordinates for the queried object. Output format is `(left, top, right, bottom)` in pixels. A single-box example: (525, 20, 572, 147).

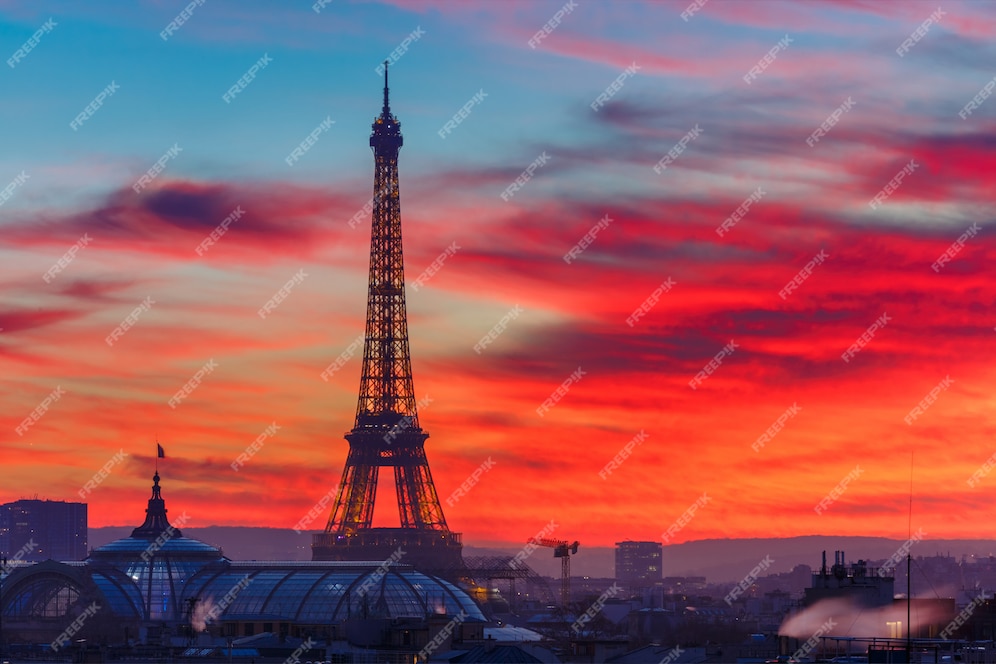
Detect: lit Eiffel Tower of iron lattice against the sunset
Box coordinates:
(311, 62, 463, 573)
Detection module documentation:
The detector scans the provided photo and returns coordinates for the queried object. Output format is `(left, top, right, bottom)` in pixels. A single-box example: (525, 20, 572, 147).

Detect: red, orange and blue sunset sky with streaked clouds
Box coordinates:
(0, 0, 996, 546)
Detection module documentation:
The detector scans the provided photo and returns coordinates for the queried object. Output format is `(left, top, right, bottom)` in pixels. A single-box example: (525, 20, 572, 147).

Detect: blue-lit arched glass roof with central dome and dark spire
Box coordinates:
(0, 472, 486, 630)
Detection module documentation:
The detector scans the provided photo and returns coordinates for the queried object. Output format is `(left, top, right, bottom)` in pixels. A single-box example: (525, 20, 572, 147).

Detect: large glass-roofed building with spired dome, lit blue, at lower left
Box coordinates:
(0, 473, 485, 649)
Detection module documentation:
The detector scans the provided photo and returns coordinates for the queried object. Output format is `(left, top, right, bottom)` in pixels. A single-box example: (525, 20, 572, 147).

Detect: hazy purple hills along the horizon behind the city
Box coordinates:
(90, 526, 996, 582)
